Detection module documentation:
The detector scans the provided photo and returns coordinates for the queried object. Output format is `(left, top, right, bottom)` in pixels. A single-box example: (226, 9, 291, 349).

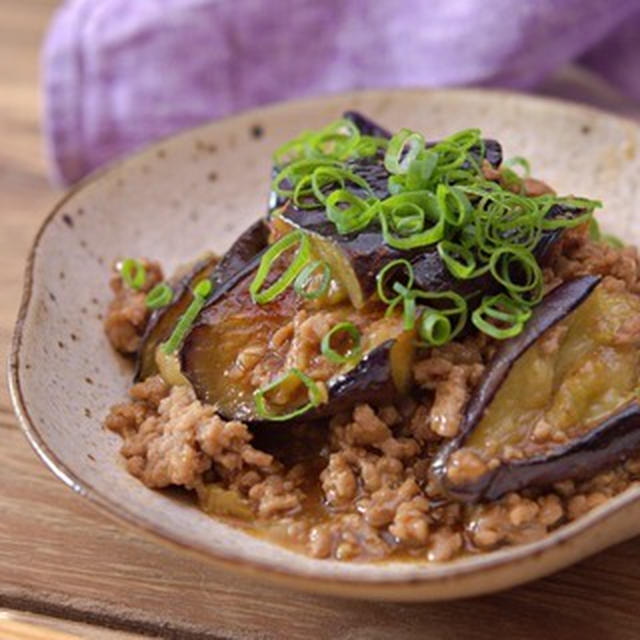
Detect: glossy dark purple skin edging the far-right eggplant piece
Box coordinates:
(431, 276, 620, 502)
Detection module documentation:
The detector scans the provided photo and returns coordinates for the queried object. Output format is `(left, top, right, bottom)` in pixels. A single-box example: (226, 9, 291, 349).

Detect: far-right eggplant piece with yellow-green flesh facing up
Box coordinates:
(432, 276, 640, 502)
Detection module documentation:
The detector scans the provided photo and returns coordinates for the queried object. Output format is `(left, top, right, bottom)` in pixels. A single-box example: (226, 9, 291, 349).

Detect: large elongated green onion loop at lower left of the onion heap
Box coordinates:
(249, 230, 311, 304)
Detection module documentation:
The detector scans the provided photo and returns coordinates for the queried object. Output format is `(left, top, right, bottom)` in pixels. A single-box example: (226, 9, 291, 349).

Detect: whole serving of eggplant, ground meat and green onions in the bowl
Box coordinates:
(105, 112, 640, 562)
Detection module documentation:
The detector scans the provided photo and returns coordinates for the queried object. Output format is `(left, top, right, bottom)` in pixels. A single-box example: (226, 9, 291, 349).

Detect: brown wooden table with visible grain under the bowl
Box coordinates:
(0, 0, 640, 640)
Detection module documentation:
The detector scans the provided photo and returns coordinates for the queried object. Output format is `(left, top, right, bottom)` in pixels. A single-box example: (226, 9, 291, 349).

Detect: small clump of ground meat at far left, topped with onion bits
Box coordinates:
(104, 260, 163, 354)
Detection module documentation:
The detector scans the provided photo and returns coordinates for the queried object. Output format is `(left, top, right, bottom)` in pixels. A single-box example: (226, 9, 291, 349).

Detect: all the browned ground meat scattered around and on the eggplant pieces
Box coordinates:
(105, 232, 640, 562)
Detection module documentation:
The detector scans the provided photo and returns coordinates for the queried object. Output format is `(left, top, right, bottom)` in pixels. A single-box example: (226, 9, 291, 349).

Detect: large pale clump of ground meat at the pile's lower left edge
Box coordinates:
(105, 376, 303, 517)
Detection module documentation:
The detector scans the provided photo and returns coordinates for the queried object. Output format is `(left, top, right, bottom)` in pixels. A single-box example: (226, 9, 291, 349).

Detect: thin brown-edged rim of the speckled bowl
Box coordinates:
(8, 87, 640, 601)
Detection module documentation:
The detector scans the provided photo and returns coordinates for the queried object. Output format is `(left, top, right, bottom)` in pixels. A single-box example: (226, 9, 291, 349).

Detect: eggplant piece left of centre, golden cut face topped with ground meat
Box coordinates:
(180, 262, 414, 422)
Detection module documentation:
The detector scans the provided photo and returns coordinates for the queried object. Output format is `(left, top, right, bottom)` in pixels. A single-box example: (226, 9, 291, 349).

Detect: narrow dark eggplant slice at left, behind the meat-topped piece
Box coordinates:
(135, 219, 269, 381)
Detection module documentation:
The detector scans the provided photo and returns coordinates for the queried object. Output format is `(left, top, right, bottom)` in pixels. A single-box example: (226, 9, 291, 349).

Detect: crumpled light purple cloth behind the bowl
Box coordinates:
(43, 0, 640, 183)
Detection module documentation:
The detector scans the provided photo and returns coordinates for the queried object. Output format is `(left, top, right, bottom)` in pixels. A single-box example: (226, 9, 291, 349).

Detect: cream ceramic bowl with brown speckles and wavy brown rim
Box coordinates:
(10, 90, 640, 600)
